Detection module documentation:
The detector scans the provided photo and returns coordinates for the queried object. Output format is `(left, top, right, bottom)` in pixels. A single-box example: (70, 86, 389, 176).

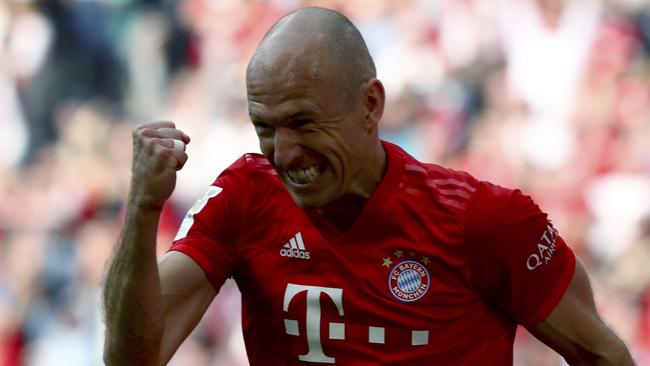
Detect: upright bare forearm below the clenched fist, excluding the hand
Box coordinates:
(103, 203, 164, 365)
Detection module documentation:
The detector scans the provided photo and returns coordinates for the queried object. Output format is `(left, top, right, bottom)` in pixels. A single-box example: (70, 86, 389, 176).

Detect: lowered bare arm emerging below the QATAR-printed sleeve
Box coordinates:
(528, 261, 634, 366)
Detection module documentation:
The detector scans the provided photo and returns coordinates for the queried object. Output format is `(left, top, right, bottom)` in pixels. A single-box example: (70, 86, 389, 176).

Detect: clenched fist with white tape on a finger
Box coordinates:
(129, 122, 190, 210)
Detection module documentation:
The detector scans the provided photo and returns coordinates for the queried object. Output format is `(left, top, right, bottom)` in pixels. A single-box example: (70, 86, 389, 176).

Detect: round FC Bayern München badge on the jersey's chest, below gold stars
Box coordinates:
(388, 260, 430, 302)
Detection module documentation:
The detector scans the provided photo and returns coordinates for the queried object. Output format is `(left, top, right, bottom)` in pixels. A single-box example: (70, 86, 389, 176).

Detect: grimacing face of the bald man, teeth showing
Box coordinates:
(247, 56, 368, 208)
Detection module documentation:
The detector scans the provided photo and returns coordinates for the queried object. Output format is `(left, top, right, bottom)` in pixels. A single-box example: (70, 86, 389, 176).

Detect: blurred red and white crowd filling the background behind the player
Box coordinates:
(0, 0, 650, 366)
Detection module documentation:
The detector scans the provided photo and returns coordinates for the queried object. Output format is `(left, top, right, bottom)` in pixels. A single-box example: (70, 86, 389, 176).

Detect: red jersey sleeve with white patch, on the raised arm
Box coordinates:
(169, 158, 248, 291)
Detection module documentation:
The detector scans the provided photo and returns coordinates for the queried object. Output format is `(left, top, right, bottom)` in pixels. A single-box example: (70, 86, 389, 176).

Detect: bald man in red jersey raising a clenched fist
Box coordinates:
(104, 8, 633, 365)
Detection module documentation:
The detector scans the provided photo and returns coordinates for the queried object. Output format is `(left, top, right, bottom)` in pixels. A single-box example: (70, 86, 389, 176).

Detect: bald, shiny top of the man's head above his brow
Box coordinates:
(247, 7, 377, 107)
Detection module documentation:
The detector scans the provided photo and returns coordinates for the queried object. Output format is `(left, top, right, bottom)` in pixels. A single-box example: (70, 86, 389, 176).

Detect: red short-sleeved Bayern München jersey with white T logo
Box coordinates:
(170, 142, 575, 365)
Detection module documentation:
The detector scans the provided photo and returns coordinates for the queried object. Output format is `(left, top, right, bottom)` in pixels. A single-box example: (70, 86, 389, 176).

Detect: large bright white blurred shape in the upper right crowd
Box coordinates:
(501, 0, 600, 115)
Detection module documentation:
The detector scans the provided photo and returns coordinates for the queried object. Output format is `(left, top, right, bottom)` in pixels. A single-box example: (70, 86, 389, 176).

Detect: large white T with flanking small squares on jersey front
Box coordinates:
(282, 283, 345, 363)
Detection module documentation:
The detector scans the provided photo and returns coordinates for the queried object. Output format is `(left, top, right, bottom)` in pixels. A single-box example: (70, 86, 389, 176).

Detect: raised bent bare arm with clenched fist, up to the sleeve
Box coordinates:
(103, 122, 216, 365)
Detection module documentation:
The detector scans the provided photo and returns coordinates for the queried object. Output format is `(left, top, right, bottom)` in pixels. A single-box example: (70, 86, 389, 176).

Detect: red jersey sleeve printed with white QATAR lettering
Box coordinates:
(467, 182, 576, 325)
